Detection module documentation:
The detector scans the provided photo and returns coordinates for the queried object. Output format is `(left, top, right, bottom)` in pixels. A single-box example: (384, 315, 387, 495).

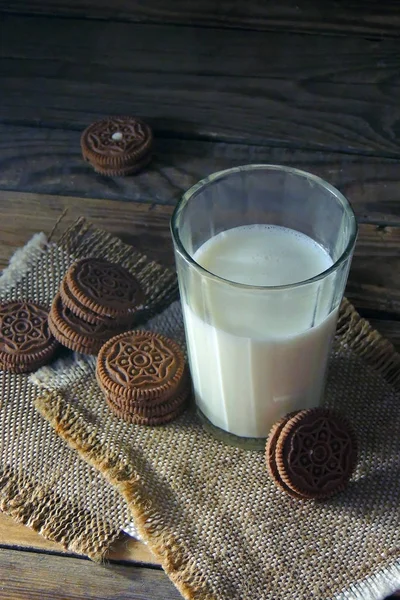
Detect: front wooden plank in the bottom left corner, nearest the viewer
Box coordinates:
(0, 549, 182, 600)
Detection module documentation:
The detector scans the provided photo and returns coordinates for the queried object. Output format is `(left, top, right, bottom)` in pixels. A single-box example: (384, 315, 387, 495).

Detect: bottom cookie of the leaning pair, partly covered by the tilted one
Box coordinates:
(49, 294, 122, 354)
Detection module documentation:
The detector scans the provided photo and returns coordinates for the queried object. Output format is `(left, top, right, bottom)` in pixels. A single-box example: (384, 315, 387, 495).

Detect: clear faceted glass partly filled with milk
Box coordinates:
(171, 165, 357, 447)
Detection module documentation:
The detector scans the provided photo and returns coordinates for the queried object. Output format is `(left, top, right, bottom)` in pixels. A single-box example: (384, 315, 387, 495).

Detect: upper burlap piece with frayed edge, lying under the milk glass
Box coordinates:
(0, 220, 400, 600)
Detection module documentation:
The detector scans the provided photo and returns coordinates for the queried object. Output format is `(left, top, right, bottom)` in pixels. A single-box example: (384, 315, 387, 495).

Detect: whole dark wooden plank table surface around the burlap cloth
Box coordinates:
(0, 0, 400, 600)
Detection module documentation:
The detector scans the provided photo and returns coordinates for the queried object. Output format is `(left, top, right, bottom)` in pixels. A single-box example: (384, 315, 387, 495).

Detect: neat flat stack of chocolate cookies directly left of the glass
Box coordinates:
(96, 331, 190, 425)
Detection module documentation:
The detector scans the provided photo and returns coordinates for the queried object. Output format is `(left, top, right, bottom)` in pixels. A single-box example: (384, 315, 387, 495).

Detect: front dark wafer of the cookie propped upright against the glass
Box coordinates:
(275, 408, 357, 500)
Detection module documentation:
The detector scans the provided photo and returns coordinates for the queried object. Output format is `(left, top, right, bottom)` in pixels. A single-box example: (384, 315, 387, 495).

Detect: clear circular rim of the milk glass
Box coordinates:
(170, 164, 358, 291)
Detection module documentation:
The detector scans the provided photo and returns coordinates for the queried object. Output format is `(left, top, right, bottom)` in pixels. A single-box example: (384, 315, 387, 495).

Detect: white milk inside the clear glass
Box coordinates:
(183, 225, 337, 437)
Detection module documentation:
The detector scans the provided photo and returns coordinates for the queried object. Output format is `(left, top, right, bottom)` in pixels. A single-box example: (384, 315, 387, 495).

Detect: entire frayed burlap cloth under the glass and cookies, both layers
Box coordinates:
(0, 220, 400, 600)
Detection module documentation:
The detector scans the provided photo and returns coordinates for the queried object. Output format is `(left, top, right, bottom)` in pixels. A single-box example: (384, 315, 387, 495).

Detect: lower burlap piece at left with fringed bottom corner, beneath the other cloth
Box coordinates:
(0, 221, 177, 560)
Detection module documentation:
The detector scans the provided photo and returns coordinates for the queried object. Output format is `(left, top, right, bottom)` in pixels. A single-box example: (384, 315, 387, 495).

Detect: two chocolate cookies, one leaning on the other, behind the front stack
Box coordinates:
(49, 258, 144, 354)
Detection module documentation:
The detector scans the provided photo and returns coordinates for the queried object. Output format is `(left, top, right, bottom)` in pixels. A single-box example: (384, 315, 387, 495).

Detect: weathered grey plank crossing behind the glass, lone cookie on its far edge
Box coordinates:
(0, 125, 400, 224)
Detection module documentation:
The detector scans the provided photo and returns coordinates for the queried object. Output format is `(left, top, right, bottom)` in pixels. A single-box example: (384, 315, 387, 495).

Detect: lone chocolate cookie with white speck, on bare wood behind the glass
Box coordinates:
(81, 117, 153, 159)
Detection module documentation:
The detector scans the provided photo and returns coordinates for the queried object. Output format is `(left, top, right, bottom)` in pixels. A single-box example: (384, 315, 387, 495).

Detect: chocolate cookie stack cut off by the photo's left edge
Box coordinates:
(0, 301, 58, 373)
